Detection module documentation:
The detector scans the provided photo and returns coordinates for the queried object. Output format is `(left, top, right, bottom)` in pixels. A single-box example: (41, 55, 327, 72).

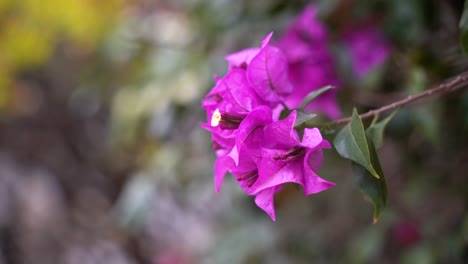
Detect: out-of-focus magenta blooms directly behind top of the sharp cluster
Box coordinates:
(277, 5, 341, 118)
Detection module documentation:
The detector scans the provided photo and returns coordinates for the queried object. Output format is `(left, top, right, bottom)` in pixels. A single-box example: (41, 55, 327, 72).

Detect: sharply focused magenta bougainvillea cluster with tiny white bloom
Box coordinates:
(202, 33, 334, 220)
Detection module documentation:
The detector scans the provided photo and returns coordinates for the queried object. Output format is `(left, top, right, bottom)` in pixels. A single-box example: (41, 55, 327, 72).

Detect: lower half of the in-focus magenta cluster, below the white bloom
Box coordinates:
(215, 110, 334, 220)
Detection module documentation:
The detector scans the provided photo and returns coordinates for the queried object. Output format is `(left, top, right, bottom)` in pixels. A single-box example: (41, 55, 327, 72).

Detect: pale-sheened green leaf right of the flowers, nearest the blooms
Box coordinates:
(333, 109, 380, 178)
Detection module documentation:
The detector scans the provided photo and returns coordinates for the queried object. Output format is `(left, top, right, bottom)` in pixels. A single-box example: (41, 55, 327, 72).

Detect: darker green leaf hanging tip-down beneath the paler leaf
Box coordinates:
(352, 138, 387, 224)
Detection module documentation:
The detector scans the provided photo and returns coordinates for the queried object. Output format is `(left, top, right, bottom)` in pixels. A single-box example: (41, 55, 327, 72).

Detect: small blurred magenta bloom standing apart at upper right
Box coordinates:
(343, 24, 391, 78)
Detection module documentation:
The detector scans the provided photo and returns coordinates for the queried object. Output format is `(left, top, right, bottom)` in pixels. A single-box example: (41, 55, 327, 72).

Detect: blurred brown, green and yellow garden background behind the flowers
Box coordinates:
(0, 0, 468, 264)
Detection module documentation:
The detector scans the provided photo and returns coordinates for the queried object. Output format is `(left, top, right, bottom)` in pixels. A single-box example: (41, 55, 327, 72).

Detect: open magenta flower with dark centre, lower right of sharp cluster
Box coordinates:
(252, 111, 334, 195)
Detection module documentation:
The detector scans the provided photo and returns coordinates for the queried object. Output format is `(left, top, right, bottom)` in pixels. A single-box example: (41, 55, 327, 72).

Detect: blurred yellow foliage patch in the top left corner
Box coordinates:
(0, 0, 123, 110)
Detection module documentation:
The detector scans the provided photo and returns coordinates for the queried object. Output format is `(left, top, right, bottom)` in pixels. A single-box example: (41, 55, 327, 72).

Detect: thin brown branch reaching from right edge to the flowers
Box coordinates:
(325, 71, 468, 126)
